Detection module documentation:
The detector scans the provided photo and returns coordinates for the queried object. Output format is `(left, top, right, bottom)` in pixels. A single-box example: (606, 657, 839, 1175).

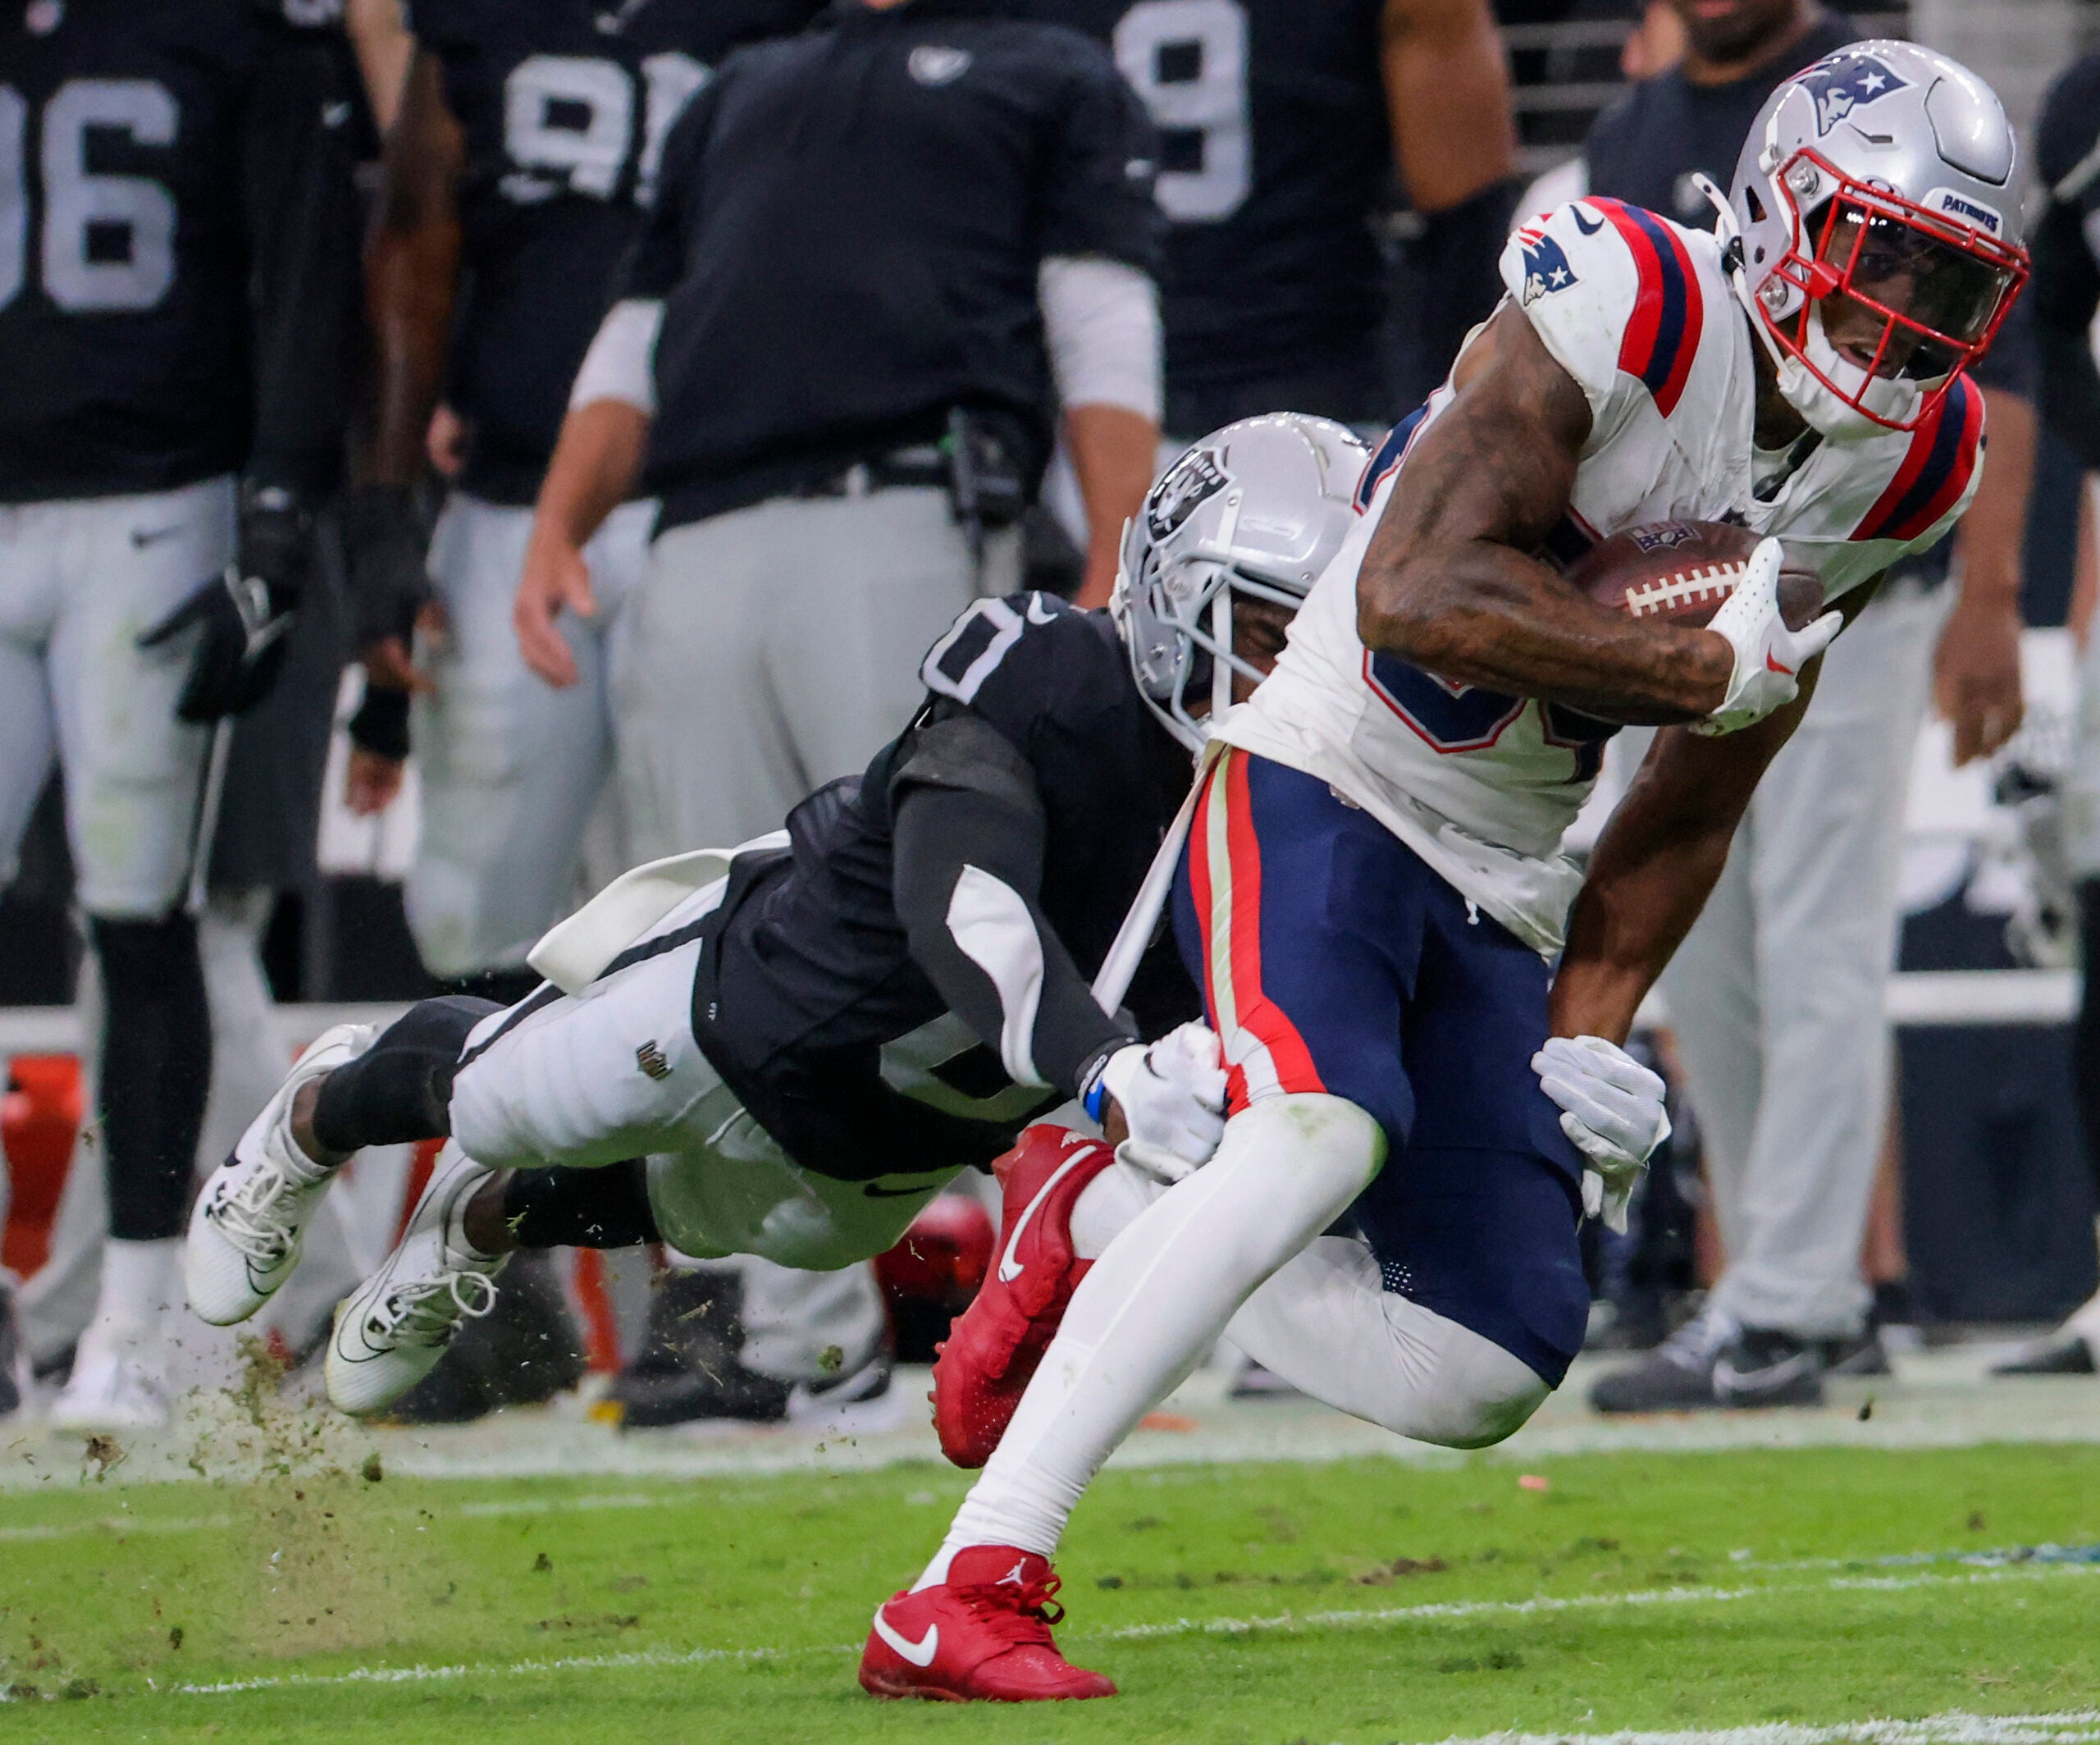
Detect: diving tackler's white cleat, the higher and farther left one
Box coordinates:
(183, 1025, 378, 1327)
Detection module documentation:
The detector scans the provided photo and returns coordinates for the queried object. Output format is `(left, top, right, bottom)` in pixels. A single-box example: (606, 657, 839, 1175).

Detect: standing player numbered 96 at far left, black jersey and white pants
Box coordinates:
(0, 0, 357, 1428)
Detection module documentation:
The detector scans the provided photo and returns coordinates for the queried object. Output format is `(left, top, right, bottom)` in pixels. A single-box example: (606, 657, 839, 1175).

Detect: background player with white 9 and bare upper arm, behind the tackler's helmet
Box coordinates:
(1014, 0, 1516, 436)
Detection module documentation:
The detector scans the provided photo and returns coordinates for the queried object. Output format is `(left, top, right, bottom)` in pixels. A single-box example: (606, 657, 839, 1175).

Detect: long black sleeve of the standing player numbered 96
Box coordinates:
(241, 21, 370, 502)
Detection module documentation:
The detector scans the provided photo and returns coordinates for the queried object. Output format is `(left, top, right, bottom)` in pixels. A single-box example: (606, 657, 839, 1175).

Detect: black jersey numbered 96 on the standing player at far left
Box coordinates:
(0, 0, 361, 502)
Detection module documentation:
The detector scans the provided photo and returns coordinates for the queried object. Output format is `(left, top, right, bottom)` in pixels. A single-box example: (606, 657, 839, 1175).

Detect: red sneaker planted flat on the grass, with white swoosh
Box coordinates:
(861, 1546, 1115, 1703)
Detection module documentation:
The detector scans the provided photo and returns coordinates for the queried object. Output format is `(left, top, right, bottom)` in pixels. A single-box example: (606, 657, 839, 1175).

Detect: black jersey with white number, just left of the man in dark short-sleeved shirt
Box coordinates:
(409, 0, 824, 504)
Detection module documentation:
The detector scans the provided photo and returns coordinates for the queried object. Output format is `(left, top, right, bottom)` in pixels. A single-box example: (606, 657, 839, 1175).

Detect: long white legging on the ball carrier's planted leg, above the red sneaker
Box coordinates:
(915, 1096, 1384, 1587)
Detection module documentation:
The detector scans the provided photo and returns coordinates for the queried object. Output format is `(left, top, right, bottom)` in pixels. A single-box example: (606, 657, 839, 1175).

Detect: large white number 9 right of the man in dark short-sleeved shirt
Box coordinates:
(1115, 0, 1253, 225)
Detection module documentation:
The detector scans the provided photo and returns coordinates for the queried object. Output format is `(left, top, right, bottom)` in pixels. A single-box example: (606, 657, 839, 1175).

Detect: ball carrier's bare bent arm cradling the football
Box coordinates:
(1357, 303, 1735, 724)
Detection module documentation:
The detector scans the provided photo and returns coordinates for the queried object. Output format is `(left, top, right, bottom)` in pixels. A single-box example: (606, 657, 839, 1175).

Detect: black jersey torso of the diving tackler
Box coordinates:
(693, 594, 1201, 1180)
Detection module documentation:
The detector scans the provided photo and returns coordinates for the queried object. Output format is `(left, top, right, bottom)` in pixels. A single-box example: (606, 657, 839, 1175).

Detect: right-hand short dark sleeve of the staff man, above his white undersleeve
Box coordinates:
(1039, 31, 1166, 273)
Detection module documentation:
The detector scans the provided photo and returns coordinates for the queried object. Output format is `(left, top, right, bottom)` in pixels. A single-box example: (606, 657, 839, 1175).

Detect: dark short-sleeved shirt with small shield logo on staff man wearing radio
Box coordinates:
(626, 0, 1159, 527)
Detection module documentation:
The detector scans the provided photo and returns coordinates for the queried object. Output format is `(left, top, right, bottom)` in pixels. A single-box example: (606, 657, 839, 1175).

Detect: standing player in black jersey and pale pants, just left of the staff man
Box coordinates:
(346, 0, 819, 991)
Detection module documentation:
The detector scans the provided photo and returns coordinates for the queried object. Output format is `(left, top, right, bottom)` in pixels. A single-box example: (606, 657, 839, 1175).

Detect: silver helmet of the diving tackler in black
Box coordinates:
(1111, 412, 1372, 751)
